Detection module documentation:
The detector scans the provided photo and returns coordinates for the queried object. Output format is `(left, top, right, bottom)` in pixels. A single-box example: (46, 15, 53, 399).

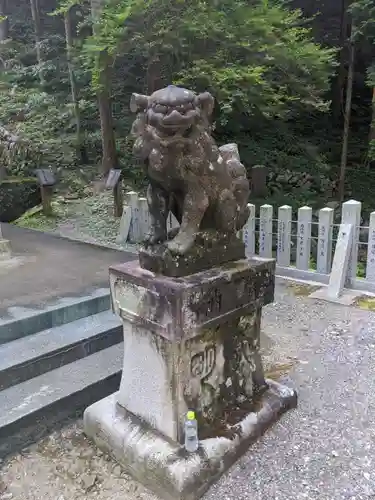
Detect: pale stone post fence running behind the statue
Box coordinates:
(119, 192, 375, 293)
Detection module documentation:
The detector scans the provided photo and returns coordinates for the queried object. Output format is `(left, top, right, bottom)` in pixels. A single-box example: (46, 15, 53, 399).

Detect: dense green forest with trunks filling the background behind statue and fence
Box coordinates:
(0, 0, 375, 215)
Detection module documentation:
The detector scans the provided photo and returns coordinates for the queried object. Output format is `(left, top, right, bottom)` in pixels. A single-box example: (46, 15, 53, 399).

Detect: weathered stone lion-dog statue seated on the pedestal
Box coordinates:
(130, 86, 249, 255)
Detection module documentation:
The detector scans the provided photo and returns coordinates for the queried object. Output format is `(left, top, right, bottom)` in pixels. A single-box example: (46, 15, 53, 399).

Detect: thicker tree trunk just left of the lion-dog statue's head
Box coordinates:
(91, 0, 117, 176)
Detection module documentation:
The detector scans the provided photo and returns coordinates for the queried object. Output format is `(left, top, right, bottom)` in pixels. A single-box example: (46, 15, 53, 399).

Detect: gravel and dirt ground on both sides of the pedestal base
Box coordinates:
(0, 281, 375, 500)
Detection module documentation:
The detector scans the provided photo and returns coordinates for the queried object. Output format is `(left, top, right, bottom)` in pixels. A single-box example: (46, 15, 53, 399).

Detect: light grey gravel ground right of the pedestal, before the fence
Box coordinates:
(206, 285, 375, 500)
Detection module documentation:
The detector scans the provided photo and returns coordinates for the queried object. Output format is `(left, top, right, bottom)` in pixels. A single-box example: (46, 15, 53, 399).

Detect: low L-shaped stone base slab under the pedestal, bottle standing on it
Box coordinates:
(84, 380, 297, 500)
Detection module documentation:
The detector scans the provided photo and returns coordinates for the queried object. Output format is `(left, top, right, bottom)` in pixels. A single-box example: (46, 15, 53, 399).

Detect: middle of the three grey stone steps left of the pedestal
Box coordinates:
(0, 310, 122, 391)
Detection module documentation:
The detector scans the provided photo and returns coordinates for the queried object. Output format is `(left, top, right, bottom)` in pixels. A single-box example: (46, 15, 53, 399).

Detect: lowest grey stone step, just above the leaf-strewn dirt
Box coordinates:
(0, 344, 123, 459)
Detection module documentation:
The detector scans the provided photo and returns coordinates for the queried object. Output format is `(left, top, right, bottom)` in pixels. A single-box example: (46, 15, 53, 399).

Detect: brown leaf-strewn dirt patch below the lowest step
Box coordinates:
(0, 421, 156, 500)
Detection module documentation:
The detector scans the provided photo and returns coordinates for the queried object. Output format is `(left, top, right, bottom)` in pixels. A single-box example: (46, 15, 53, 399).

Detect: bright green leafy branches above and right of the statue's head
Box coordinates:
(175, 1, 334, 120)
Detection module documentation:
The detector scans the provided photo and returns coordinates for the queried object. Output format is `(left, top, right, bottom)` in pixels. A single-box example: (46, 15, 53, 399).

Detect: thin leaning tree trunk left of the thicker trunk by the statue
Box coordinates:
(64, 8, 87, 163)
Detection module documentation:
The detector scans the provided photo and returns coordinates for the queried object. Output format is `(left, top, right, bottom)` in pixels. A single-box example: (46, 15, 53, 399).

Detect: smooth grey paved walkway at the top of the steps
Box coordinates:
(0, 224, 134, 310)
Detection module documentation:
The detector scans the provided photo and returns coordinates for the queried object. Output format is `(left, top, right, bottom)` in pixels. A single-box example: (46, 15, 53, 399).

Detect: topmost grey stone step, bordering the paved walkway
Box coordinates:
(0, 288, 111, 344)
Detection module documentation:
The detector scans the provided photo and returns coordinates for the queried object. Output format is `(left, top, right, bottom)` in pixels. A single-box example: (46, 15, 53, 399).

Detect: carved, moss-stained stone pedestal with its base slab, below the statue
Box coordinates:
(84, 259, 296, 500)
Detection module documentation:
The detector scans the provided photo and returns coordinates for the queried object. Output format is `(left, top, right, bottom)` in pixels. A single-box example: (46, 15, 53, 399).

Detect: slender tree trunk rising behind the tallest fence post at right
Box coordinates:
(338, 33, 355, 203)
